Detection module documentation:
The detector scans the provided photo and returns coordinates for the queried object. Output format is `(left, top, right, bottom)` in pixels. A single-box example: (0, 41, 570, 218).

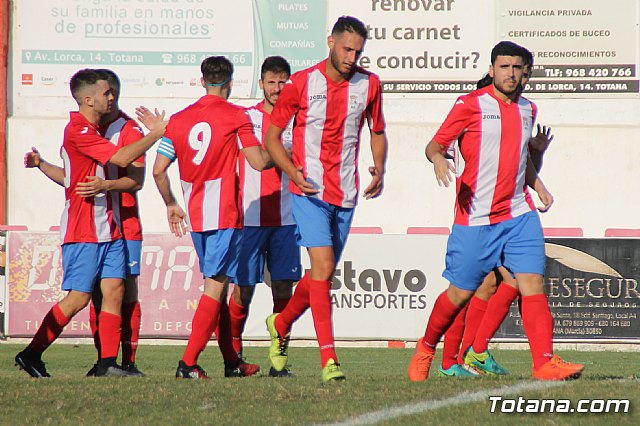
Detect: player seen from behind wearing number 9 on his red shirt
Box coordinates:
(153, 56, 270, 379)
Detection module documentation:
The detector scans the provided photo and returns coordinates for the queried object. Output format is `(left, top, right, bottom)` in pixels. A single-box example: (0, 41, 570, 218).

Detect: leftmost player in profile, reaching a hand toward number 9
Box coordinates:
(15, 69, 166, 378)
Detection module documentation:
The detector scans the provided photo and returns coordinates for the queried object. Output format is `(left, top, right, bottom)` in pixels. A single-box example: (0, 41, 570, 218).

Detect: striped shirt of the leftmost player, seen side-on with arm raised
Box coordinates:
(60, 112, 122, 244)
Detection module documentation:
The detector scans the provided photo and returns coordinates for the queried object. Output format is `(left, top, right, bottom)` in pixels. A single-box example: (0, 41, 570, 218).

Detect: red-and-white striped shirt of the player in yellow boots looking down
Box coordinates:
(271, 60, 385, 208)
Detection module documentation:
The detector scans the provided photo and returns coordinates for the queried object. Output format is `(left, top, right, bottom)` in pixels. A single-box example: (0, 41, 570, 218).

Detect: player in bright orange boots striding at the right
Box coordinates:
(409, 42, 584, 381)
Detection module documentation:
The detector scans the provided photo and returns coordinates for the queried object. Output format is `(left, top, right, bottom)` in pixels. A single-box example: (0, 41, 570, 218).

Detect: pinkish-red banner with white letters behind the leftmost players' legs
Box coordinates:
(7, 232, 204, 337)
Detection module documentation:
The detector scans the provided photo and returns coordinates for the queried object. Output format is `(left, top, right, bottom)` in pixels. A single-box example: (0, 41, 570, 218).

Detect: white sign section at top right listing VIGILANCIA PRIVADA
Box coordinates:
(498, 0, 640, 94)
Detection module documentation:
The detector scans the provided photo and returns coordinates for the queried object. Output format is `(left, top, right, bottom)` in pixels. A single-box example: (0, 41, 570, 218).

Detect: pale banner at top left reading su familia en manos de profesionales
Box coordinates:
(12, 0, 326, 98)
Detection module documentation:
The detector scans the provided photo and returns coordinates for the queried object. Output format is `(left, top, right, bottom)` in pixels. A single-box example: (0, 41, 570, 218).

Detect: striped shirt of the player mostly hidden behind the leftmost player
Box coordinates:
(98, 111, 145, 241)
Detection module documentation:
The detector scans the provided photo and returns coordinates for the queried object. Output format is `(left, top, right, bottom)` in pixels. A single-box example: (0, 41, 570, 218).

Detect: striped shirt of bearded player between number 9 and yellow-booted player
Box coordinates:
(238, 101, 295, 226)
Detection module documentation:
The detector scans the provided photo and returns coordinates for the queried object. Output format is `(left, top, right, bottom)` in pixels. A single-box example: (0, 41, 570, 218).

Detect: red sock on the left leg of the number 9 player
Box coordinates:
(182, 294, 220, 366)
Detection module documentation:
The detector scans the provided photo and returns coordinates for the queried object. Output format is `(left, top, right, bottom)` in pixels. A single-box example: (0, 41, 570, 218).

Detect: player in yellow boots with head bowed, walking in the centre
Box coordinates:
(265, 16, 387, 381)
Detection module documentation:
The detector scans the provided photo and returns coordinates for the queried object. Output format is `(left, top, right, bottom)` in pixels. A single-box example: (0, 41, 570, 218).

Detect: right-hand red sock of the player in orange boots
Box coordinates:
(522, 294, 553, 370)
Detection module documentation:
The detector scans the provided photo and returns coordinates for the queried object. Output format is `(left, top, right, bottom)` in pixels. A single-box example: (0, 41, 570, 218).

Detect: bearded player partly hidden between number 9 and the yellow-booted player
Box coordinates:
(229, 56, 302, 376)
